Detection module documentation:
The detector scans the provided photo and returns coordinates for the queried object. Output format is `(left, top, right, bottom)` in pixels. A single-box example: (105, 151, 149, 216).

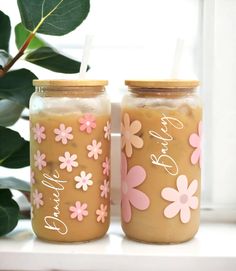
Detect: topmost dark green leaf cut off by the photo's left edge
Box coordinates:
(0, 11, 11, 52)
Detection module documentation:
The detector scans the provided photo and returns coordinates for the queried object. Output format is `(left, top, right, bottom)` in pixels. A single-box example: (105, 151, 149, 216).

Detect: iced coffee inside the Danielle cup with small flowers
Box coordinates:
(30, 113, 110, 242)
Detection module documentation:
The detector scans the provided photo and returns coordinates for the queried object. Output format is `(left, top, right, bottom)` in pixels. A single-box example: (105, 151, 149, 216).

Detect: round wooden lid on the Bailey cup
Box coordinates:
(125, 79, 199, 89)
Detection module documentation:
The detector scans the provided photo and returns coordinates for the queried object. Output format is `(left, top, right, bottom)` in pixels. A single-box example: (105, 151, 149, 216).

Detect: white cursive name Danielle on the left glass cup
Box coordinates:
(42, 170, 68, 235)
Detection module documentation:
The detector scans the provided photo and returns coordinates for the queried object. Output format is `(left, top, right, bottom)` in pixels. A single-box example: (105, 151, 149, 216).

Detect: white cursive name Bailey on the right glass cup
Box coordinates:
(149, 113, 184, 176)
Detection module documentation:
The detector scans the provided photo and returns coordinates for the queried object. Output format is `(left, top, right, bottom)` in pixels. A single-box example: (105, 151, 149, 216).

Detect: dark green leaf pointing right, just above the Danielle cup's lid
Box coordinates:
(25, 47, 83, 73)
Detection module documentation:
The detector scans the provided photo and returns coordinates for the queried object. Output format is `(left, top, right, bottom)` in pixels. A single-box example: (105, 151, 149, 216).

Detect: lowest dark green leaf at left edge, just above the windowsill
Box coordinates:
(0, 189, 20, 236)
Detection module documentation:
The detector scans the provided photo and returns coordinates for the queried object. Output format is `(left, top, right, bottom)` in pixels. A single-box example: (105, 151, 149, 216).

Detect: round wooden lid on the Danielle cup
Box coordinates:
(33, 80, 108, 87)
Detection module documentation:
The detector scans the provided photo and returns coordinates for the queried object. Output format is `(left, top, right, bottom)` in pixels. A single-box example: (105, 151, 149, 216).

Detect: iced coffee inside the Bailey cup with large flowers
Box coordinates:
(121, 104, 202, 243)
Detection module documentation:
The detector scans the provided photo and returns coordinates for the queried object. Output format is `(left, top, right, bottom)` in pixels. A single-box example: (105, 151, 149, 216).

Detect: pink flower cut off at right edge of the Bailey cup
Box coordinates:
(189, 121, 202, 167)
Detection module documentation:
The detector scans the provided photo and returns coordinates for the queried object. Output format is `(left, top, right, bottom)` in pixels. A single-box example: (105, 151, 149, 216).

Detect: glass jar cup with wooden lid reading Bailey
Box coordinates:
(121, 80, 202, 243)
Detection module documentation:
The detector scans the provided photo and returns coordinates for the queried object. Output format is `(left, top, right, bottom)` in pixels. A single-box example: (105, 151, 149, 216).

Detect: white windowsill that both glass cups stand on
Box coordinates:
(0, 218, 236, 271)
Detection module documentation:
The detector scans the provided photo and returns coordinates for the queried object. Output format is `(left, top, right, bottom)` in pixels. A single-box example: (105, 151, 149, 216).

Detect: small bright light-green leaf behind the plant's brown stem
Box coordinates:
(15, 23, 46, 50)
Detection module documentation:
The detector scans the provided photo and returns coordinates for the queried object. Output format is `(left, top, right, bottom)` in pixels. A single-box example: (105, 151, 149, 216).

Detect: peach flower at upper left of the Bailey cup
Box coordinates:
(121, 113, 143, 157)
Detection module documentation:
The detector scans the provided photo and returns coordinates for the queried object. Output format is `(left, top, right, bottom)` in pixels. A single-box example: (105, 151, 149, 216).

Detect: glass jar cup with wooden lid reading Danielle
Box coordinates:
(30, 80, 111, 242)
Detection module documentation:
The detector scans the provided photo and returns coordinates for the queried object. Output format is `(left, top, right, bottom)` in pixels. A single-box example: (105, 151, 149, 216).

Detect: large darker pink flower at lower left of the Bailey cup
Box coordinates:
(121, 153, 150, 223)
